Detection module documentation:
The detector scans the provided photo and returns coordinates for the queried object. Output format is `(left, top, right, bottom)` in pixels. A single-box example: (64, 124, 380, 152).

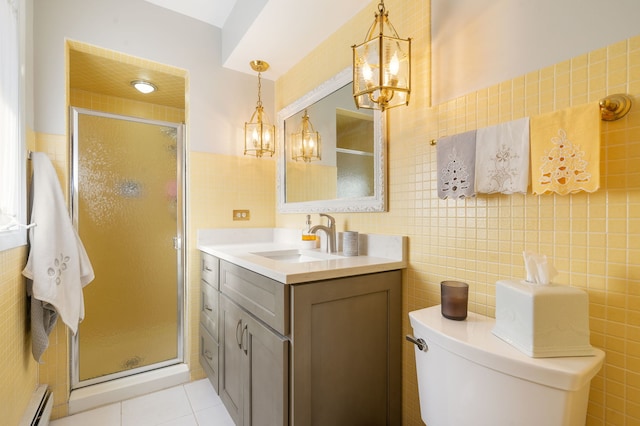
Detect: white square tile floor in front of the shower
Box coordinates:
(50, 379, 233, 426)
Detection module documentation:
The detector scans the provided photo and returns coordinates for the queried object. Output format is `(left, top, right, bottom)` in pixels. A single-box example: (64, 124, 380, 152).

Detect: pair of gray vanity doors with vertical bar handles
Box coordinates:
(220, 295, 289, 426)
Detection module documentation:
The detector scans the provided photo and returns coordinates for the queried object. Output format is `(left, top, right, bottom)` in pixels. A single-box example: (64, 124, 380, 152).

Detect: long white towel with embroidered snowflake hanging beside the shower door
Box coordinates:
(22, 152, 94, 340)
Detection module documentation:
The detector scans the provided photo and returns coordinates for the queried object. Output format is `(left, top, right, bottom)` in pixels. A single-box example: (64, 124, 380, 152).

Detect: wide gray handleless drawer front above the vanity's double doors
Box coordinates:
(220, 260, 289, 336)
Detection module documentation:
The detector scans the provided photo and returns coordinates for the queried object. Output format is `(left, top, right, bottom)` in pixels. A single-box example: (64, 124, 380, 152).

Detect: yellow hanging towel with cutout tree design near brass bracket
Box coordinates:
(531, 103, 601, 195)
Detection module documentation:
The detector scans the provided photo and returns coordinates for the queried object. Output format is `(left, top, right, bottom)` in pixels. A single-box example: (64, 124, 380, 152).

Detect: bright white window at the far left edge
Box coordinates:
(0, 0, 26, 250)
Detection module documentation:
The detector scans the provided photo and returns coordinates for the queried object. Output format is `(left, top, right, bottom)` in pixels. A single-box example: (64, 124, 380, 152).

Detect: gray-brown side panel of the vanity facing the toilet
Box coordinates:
(290, 271, 402, 426)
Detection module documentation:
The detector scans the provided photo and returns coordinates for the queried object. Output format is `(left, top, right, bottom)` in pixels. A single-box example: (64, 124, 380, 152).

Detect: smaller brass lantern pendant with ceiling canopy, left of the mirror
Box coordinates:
(244, 60, 276, 157)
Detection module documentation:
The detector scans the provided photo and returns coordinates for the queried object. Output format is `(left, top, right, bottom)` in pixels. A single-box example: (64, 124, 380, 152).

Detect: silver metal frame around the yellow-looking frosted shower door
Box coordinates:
(69, 107, 186, 390)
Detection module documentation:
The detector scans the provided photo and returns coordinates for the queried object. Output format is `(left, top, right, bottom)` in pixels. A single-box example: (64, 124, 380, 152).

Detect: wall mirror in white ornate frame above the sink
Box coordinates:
(277, 67, 387, 213)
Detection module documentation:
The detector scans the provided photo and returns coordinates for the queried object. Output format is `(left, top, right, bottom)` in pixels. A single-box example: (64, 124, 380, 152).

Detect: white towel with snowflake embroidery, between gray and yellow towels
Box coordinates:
(476, 117, 529, 194)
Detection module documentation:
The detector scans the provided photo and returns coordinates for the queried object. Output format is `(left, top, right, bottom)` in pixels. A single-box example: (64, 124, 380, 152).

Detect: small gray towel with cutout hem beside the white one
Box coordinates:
(437, 130, 476, 200)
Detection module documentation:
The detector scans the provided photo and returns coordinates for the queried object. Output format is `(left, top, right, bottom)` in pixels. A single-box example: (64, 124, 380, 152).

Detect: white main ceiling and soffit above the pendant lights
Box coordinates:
(140, 0, 370, 80)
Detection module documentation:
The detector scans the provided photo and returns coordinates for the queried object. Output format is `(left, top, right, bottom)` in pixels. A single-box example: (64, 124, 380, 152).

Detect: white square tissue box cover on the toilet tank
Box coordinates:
(493, 280, 594, 358)
